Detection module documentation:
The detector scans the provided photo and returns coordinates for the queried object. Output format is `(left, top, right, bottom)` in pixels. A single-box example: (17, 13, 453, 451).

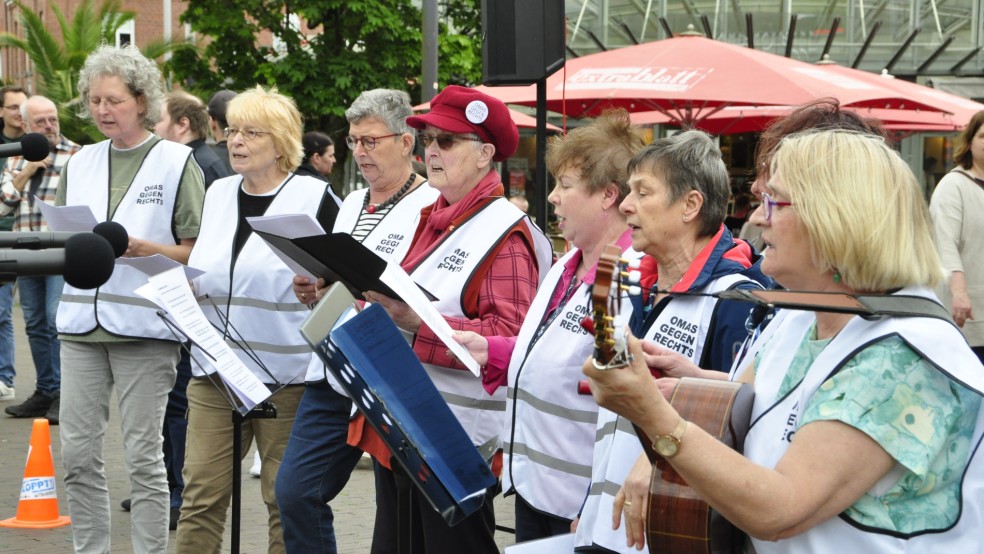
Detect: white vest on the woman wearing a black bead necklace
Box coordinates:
(305, 182, 439, 384)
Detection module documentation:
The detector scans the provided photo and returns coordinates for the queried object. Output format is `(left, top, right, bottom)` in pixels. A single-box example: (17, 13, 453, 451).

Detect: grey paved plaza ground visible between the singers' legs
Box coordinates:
(0, 300, 514, 554)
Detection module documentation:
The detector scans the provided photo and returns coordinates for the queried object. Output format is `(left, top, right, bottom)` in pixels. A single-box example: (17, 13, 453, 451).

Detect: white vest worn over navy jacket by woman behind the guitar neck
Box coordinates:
(575, 274, 755, 554)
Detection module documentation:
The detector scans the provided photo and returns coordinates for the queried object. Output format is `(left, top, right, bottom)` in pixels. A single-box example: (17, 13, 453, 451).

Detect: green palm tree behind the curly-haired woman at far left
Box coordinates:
(0, 0, 180, 144)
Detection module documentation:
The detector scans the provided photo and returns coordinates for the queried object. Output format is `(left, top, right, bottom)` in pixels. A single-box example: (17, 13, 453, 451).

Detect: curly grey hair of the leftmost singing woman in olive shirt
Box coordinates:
(79, 44, 164, 129)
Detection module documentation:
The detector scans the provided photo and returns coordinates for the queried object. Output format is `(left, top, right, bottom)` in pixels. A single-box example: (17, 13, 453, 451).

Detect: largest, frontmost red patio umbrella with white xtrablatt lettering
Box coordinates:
(472, 36, 937, 123)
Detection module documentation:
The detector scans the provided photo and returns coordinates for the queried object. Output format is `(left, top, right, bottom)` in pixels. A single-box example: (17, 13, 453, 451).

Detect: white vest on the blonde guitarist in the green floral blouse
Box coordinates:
(744, 287, 984, 554)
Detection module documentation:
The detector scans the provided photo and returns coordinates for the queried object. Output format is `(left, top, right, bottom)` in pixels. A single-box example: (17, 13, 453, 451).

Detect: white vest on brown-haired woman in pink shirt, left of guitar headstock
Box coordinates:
(502, 249, 641, 519)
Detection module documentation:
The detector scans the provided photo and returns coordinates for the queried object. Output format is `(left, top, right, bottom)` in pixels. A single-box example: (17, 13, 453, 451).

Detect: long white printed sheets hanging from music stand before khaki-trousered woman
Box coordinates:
(136, 267, 270, 410)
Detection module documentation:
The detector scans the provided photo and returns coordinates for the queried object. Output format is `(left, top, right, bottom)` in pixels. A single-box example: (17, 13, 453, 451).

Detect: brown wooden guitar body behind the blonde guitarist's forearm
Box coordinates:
(640, 378, 753, 554)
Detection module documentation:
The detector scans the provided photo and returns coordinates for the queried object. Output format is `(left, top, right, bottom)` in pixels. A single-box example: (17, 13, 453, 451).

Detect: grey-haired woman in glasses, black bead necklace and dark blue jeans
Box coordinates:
(277, 89, 437, 554)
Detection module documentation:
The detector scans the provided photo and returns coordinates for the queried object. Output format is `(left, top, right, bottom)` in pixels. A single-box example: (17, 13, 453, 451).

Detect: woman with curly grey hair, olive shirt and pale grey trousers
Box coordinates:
(56, 45, 205, 553)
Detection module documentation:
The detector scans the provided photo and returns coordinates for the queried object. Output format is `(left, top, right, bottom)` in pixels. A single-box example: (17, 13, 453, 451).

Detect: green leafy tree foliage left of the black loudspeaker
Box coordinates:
(169, 0, 481, 137)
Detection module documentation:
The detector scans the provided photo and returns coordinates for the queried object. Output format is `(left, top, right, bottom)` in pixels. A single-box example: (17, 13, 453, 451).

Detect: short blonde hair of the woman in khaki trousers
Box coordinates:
(226, 85, 304, 173)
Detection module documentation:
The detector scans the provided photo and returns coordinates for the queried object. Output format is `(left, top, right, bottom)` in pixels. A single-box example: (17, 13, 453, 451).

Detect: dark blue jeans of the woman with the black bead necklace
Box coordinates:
(276, 383, 362, 554)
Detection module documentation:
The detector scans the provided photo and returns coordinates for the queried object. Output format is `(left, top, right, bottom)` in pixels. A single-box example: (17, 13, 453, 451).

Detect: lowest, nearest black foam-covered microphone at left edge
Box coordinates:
(0, 233, 115, 289)
